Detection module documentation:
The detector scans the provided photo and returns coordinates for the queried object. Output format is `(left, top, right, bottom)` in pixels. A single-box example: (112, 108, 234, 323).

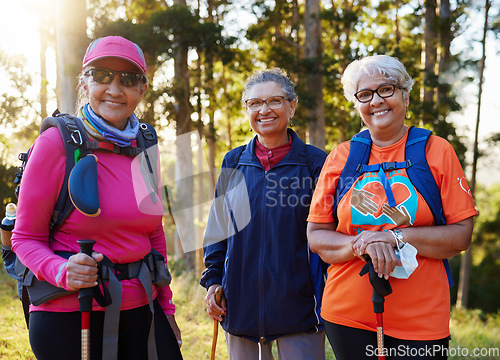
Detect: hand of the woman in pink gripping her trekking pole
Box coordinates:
(66, 252, 104, 290)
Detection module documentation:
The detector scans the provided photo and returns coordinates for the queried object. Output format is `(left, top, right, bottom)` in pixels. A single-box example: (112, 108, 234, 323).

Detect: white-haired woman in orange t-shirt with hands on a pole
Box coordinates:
(308, 55, 477, 360)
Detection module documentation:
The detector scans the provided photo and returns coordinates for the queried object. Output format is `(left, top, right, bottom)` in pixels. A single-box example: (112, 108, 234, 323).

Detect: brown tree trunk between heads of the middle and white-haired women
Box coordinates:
(305, 0, 326, 149)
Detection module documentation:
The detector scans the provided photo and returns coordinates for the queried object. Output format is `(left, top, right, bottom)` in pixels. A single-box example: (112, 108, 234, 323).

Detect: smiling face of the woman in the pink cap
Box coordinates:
(82, 57, 147, 130)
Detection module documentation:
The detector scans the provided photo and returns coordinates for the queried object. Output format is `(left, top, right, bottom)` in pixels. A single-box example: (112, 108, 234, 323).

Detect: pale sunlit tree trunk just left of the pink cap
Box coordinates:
(54, 0, 87, 113)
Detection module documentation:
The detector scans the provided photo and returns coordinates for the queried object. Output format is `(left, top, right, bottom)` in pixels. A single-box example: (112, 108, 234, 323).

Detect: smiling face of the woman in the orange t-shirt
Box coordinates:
(356, 76, 410, 145)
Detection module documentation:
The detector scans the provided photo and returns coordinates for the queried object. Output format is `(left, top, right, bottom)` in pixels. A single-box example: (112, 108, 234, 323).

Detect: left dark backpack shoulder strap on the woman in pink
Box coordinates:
(40, 113, 88, 231)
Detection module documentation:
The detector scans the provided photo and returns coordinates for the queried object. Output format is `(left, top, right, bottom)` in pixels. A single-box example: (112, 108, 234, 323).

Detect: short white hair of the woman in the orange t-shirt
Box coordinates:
(341, 55, 415, 107)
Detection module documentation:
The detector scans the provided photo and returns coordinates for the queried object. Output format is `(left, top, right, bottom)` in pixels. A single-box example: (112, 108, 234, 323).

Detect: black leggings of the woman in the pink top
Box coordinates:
(29, 301, 182, 360)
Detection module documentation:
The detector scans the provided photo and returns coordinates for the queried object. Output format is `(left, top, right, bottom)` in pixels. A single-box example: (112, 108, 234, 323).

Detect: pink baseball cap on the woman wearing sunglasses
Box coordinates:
(82, 36, 147, 75)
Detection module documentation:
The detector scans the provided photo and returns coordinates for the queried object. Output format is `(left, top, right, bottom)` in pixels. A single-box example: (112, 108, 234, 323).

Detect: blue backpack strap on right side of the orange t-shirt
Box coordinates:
(405, 126, 453, 287)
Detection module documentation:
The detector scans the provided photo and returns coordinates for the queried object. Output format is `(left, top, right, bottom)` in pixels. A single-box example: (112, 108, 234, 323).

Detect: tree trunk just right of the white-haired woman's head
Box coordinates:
(420, 0, 438, 125)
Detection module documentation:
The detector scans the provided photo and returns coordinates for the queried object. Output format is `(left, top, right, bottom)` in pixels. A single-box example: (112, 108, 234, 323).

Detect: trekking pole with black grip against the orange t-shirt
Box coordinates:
(359, 255, 392, 360)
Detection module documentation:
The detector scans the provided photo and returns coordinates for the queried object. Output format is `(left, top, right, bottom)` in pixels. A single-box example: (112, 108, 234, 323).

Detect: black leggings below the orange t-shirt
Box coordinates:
(325, 321, 449, 360)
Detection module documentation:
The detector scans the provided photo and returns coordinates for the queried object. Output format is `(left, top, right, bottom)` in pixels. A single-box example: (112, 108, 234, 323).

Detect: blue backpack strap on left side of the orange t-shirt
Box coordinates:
(333, 130, 372, 222)
